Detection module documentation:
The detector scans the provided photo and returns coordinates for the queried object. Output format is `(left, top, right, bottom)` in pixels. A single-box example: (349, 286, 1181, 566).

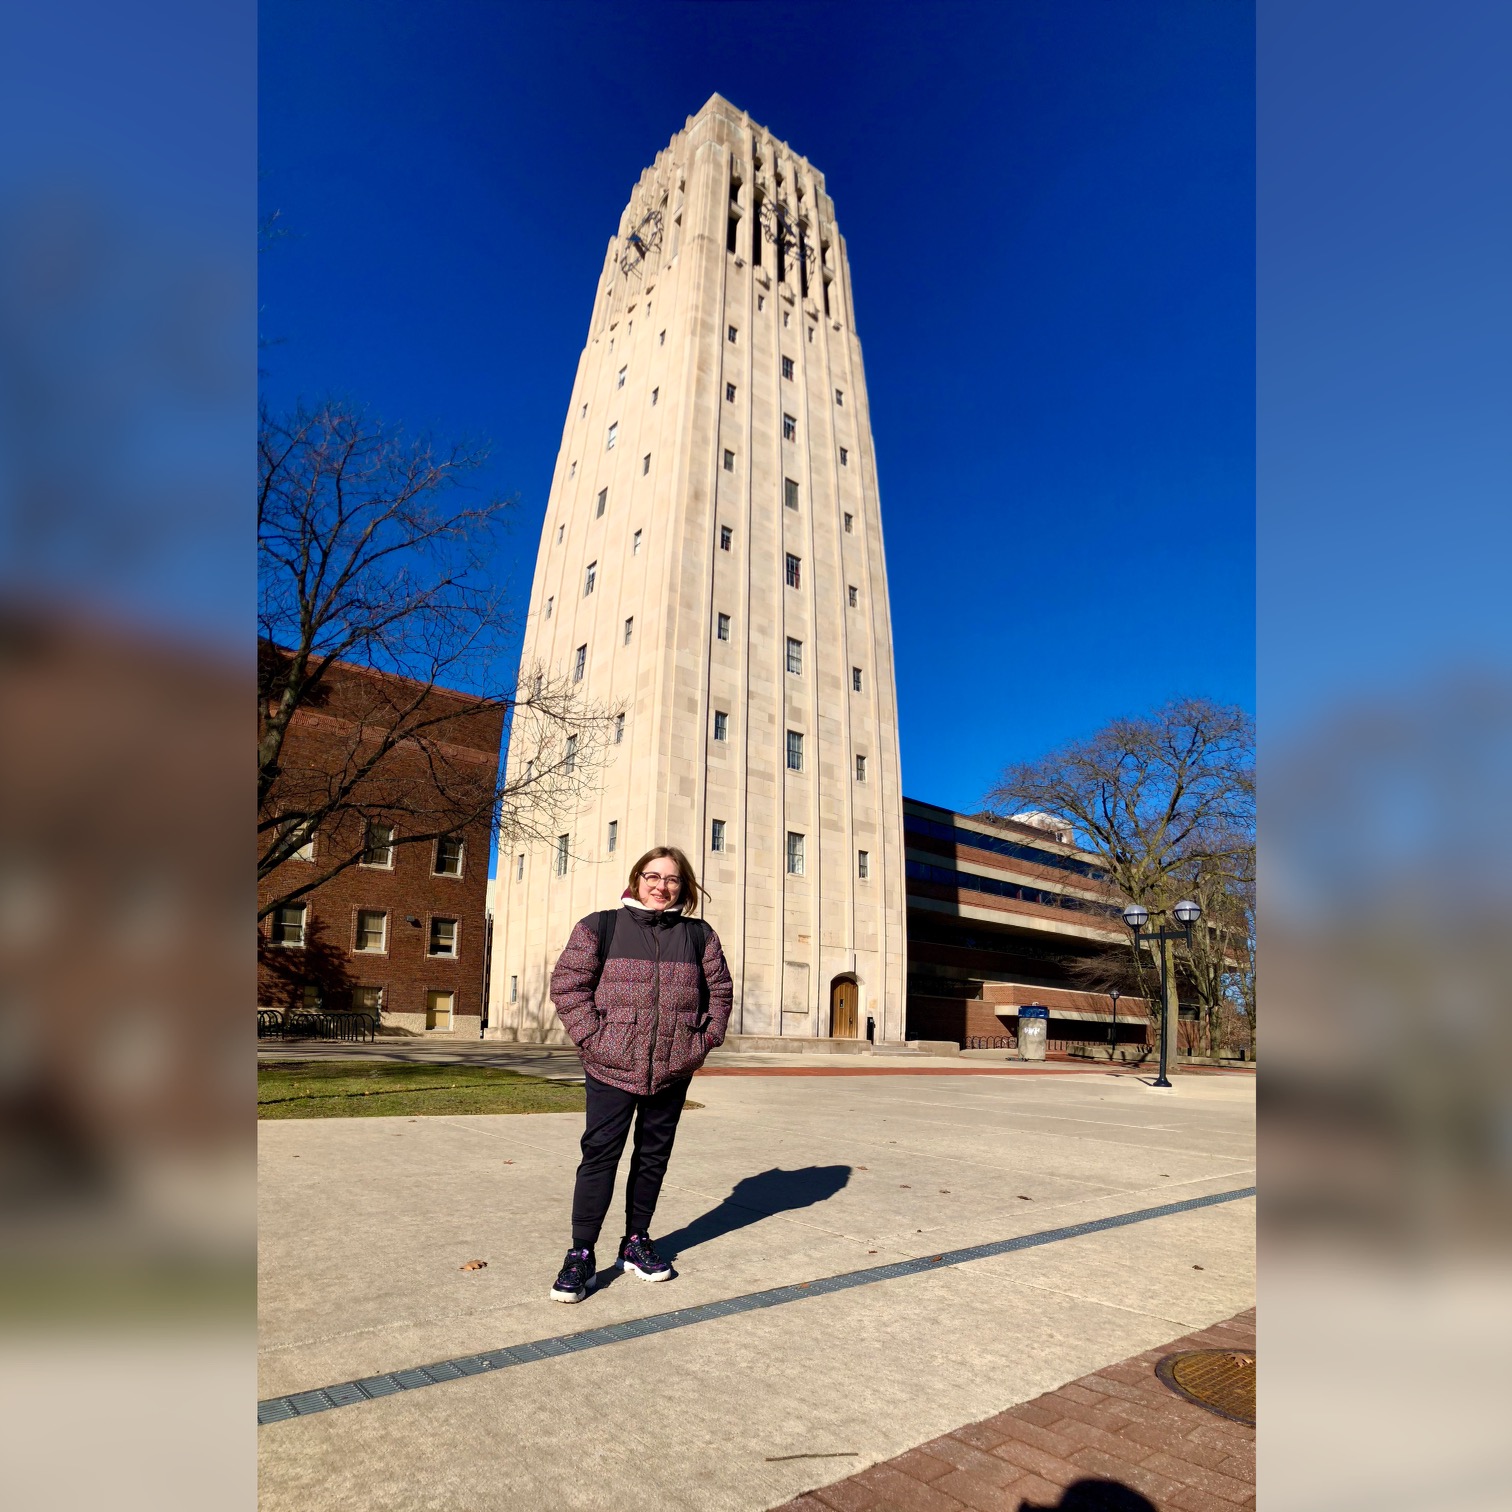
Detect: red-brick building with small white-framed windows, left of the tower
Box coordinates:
(257, 667, 503, 1037)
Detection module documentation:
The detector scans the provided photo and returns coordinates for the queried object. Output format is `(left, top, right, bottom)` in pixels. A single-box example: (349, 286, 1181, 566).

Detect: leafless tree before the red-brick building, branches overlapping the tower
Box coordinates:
(257, 402, 612, 918)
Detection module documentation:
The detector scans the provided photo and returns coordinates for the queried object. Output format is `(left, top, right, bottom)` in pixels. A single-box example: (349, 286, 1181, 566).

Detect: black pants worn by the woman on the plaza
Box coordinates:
(572, 1075, 692, 1249)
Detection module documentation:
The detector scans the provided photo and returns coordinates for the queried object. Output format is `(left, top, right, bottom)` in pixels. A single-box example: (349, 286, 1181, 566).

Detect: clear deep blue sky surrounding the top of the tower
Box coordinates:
(259, 0, 1255, 809)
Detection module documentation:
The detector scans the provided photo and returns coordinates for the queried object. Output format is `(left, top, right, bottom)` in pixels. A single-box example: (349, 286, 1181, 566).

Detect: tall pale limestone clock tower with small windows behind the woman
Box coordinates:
(488, 95, 906, 1042)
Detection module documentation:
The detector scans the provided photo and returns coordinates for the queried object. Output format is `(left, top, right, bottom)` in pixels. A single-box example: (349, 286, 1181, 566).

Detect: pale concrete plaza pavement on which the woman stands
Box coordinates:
(260, 1061, 1253, 1512)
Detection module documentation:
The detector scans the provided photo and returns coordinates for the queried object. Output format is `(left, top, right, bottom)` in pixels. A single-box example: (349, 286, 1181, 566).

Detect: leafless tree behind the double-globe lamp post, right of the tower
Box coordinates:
(986, 699, 1255, 1046)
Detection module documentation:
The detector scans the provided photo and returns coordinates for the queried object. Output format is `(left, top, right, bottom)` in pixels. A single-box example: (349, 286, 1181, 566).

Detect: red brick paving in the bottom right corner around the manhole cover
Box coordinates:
(779, 1308, 1255, 1512)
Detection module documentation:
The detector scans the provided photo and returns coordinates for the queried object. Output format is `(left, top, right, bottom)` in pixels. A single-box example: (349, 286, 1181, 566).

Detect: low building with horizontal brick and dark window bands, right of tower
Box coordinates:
(903, 798, 1196, 1049)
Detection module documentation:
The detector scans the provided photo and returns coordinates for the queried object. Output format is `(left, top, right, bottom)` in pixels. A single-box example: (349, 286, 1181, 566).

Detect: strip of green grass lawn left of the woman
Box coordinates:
(257, 1060, 703, 1119)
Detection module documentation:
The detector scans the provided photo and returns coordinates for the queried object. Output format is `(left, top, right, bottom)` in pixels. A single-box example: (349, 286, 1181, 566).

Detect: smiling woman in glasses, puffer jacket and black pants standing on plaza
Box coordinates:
(550, 845, 733, 1302)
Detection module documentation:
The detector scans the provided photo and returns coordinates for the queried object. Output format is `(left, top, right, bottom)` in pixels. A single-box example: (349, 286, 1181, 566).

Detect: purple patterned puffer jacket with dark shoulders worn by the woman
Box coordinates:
(552, 904, 735, 1096)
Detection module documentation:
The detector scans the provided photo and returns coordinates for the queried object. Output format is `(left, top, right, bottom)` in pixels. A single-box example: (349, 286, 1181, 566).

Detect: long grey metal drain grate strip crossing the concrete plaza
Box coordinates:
(257, 1187, 1255, 1426)
